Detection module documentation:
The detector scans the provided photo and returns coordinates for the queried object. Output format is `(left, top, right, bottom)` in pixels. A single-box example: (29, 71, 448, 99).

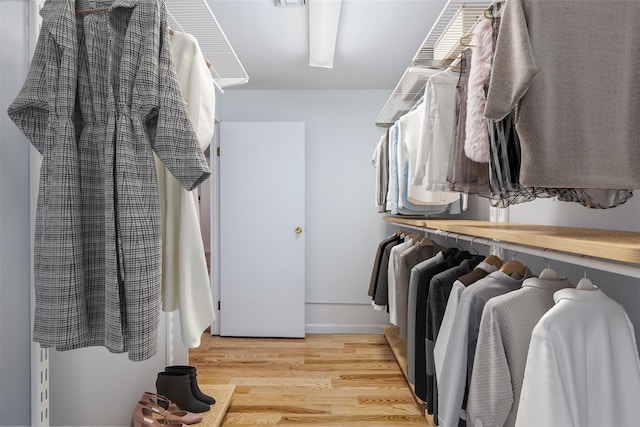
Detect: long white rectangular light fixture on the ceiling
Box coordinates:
(308, 0, 342, 68)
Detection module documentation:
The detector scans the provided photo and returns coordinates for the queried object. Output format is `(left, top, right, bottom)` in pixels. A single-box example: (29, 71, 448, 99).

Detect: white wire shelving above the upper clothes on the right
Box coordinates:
(376, 0, 494, 127)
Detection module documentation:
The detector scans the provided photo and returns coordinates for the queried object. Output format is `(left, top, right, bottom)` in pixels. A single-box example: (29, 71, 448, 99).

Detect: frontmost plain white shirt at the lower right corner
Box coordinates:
(516, 289, 640, 427)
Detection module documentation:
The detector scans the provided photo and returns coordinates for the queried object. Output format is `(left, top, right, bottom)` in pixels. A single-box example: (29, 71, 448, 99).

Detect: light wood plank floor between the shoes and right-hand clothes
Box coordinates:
(190, 333, 430, 427)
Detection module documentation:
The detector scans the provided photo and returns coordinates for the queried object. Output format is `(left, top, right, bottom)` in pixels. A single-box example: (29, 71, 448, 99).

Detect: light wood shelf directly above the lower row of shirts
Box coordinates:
(384, 216, 640, 264)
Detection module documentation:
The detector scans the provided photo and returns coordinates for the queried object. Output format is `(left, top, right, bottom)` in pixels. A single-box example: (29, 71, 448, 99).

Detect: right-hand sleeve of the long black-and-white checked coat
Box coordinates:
(146, 2, 211, 190)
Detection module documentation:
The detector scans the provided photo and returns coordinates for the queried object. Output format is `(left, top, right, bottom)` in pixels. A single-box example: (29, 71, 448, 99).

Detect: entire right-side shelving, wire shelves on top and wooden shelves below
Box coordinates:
(376, 0, 640, 426)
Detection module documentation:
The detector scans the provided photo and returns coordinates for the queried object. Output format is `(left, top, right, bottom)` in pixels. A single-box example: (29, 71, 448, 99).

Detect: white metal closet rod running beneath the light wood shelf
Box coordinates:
(391, 221, 640, 279)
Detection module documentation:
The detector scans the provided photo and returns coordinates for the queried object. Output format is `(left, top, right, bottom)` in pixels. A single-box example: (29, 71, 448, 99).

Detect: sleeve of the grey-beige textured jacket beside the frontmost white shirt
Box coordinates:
(467, 301, 513, 427)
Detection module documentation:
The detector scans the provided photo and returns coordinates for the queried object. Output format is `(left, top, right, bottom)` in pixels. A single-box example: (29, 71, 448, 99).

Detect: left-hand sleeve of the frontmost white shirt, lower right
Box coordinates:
(516, 322, 581, 427)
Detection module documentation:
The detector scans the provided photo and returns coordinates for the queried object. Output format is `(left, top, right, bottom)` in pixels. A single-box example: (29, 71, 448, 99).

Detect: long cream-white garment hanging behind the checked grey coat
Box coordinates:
(156, 31, 216, 348)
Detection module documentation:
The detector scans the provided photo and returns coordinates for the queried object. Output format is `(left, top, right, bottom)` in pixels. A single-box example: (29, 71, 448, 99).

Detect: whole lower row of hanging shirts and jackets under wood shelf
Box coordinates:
(368, 232, 640, 427)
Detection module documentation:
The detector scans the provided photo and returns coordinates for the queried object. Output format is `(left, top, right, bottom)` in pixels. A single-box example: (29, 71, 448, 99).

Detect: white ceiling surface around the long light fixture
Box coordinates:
(207, 0, 446, 90)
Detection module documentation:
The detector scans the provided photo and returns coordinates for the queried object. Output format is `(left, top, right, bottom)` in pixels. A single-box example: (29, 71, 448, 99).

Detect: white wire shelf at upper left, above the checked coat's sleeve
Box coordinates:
(166, 0, 249, 88)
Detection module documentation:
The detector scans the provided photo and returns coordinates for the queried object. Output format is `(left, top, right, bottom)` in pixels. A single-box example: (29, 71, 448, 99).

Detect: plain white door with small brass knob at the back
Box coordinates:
(219, 122, 305, 337)
